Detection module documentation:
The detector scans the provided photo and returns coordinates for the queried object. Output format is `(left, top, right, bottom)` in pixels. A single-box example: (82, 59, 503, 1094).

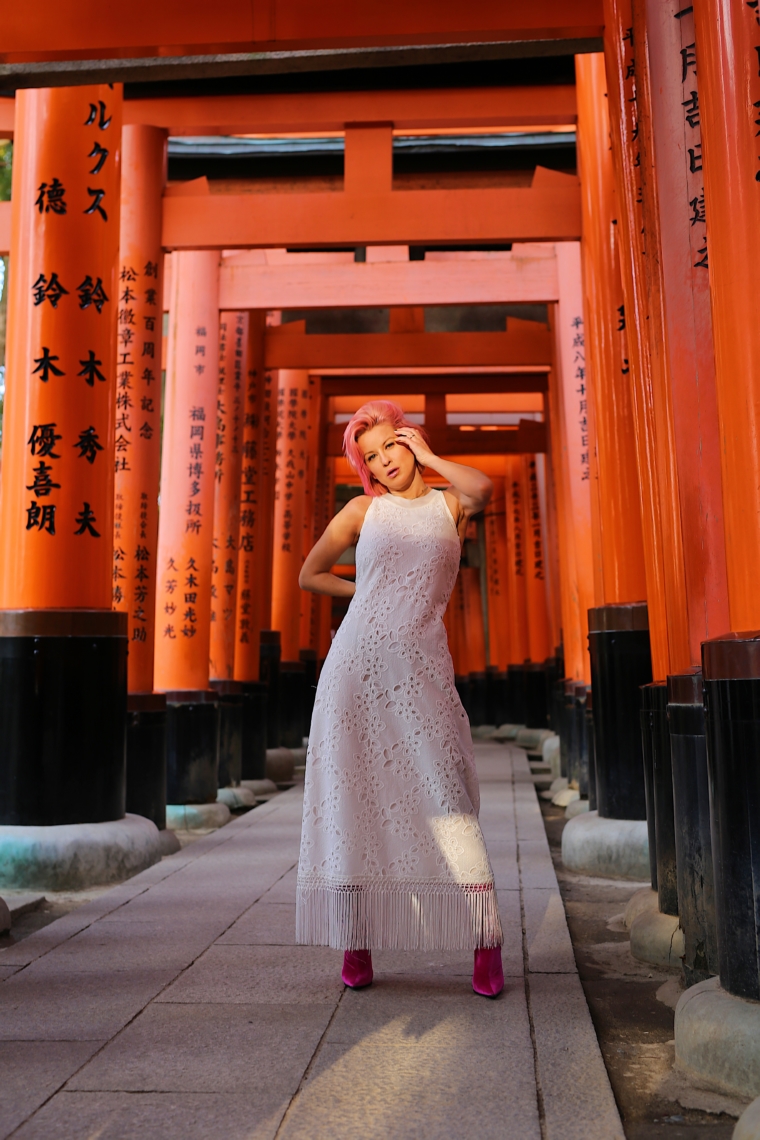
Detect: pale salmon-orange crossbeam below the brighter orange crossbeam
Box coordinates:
(219, 245, 558, 309)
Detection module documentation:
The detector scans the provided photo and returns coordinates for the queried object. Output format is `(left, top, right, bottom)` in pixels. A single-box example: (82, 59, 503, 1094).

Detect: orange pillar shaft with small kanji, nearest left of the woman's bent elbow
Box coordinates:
(272, 368, 309, 661)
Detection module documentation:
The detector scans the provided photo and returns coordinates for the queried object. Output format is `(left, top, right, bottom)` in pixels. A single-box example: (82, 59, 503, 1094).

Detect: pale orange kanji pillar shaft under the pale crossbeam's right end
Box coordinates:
(551, 242, 594, 682)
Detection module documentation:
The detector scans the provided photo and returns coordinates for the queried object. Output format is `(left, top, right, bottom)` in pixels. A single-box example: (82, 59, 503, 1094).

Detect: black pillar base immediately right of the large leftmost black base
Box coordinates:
(126, 693, 166, 831)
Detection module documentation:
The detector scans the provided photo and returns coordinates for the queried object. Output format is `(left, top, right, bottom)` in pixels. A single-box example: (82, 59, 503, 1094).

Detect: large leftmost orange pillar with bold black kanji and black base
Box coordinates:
(0, 91, 132, 839)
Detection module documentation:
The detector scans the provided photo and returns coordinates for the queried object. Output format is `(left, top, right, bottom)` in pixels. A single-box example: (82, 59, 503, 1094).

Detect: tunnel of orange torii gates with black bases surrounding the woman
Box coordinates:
(0, 0, 760, 1067)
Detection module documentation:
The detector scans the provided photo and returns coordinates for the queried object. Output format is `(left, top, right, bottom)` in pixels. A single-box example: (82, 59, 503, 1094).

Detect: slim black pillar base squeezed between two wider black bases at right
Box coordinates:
(641, 682, 678, 918)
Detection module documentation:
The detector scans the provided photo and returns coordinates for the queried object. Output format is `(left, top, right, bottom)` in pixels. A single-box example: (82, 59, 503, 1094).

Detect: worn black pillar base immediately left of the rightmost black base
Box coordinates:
(668, 670, 718, 986)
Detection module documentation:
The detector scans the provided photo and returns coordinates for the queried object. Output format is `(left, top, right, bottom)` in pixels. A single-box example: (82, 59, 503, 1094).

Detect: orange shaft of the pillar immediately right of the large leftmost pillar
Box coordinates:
(113, 127, 166, 693)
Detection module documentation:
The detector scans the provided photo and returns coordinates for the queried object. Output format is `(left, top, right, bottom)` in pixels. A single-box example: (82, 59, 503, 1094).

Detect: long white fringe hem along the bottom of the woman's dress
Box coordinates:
(295, 881, 504, 950)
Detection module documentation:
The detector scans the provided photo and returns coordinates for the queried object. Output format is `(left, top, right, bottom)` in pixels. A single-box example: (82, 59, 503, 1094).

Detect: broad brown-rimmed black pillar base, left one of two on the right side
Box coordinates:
(588, 602, 652, 820)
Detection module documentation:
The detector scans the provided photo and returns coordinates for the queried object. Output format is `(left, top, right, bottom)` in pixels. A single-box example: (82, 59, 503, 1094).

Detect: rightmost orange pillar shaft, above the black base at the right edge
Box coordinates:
(694, 0, 760, 630)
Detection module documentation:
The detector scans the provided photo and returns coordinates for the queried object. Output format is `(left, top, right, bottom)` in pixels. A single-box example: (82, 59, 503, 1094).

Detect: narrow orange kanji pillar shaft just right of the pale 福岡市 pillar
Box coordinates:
(209, 312, 250, 681)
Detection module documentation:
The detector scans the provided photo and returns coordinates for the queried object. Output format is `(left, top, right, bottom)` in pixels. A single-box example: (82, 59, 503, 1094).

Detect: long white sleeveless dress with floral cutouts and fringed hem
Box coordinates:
(296, 490, 502, 950)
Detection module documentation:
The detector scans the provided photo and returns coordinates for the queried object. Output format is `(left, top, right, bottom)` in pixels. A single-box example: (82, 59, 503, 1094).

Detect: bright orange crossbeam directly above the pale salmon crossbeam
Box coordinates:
(163, 184, 581, 250)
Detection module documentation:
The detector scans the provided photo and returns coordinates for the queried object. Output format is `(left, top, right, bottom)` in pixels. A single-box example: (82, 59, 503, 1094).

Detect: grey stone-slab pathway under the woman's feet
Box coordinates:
(0, 743, 623, 1140)
